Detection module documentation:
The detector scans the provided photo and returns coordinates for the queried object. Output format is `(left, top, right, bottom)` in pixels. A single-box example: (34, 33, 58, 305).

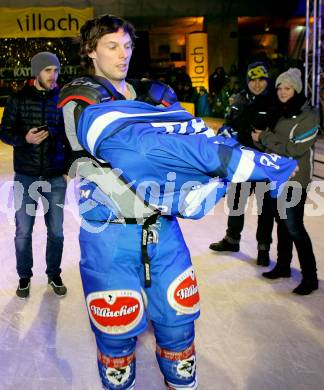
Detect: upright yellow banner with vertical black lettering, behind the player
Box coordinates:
(186, 32, 208, 91)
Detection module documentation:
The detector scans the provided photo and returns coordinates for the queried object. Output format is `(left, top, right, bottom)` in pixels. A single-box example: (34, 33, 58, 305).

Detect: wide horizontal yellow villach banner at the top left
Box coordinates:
(0, 7, 93, 38)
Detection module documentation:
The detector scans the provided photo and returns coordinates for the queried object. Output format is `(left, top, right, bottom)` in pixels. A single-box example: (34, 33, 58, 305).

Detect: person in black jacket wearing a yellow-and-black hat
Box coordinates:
(209, 62, 275, 266)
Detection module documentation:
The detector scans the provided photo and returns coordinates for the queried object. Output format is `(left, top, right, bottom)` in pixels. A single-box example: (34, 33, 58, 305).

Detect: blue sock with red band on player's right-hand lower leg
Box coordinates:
(154, 323, 198, 390)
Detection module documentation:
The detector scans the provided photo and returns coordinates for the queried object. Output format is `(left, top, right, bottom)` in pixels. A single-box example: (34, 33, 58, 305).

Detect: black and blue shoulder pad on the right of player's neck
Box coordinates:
(131, 78, 178, 107)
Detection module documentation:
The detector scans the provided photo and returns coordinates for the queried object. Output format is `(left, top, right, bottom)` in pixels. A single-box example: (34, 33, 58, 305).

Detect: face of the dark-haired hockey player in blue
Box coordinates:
(89, 29, 133, 82)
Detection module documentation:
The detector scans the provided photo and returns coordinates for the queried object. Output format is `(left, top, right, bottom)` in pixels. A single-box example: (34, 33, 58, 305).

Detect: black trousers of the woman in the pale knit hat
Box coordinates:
(272, 187, 317, 280)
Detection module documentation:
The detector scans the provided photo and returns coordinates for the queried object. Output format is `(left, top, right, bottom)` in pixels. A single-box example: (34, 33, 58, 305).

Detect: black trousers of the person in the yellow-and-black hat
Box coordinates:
(225, 183, 274, 250)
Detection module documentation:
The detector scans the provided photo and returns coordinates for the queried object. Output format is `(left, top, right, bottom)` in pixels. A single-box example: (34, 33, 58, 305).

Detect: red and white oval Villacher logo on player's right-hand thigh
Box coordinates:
(167, 266, 200, 314)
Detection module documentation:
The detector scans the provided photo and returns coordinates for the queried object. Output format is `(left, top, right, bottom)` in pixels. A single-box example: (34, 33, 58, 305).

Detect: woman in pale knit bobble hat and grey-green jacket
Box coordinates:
(252, 68, 319, 295)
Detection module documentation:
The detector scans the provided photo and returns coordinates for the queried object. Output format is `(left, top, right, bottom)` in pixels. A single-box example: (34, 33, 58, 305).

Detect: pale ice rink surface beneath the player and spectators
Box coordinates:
(0, 143, 324, 390)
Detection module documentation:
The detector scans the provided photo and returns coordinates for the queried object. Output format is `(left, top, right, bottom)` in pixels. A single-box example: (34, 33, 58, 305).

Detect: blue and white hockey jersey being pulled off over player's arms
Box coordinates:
(77, 100, 296, 219)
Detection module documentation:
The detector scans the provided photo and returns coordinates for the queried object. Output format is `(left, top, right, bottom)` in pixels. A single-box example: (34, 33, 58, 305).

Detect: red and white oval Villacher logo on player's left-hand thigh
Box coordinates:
(87, 290, 144, 334)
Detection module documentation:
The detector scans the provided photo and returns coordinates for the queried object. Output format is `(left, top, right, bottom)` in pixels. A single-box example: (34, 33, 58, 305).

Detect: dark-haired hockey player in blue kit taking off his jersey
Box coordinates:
(60, 15, 295, 390)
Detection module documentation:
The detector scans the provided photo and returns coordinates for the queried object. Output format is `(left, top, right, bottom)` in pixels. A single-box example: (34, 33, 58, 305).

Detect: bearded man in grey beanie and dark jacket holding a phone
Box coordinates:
(0, 52, 67, 299)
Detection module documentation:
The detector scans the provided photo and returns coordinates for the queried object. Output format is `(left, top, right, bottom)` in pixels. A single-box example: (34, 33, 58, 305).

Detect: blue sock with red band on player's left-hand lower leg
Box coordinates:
(97, 337, 136, 390)
